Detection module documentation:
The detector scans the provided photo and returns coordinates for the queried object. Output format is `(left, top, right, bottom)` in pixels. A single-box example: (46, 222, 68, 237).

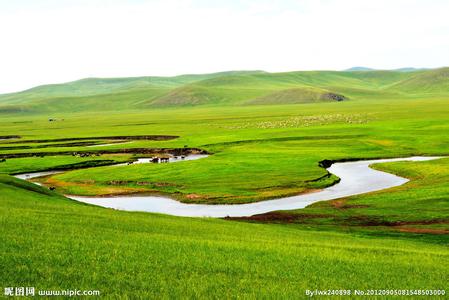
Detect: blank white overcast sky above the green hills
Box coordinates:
(0, 0, 449, 93)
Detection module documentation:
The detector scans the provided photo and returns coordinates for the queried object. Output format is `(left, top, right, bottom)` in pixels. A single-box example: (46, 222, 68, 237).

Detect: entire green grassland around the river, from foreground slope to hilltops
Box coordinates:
(0, 68, 449, 298)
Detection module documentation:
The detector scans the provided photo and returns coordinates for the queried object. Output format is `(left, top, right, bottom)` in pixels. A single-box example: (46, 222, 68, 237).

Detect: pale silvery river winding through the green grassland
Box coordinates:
(16, 156, 441, 218)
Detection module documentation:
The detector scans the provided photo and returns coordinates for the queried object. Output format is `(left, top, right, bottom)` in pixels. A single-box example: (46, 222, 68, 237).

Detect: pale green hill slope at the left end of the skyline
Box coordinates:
(0, 71, 262, 111)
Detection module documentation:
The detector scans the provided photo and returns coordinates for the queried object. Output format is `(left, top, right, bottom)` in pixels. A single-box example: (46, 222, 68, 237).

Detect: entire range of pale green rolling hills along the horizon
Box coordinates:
(0, 67, 449, 113)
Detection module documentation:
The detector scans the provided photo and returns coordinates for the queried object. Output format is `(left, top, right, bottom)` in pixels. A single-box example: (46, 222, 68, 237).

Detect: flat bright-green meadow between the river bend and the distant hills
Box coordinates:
(0, 98, 449, 203)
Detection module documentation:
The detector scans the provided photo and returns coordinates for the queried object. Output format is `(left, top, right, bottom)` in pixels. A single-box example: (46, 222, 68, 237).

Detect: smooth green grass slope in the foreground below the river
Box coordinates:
(0, 175, 449, 298)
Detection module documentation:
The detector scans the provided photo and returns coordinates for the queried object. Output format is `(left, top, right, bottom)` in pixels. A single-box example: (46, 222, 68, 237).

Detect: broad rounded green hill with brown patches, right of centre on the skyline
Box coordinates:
(149, 71, 411, 106)
